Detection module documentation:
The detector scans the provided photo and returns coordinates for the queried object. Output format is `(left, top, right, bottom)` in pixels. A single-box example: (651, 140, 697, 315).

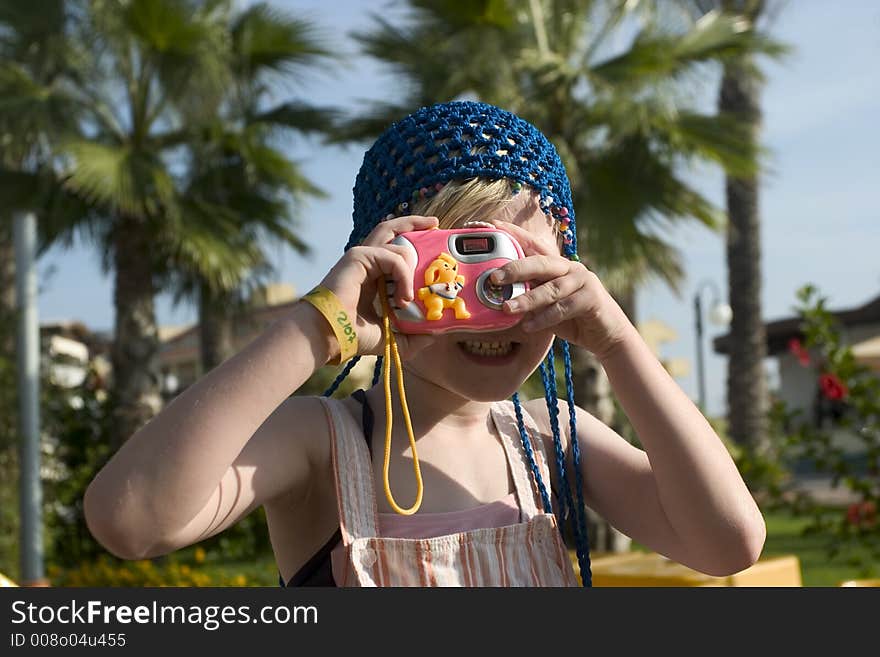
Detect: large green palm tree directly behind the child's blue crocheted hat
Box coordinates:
(344, 0, 775, 549)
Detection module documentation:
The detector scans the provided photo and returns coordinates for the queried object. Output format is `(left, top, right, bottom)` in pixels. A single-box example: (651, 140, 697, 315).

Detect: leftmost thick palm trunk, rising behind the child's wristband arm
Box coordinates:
(111, 217, 162, 450)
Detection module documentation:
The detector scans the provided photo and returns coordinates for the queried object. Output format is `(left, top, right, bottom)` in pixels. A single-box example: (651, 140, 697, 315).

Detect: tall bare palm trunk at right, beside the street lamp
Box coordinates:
(718, 60, 768, 450)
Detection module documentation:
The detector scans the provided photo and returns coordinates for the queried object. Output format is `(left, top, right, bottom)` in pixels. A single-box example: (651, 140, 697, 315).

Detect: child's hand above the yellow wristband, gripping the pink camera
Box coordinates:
(321, 215, 438, 359)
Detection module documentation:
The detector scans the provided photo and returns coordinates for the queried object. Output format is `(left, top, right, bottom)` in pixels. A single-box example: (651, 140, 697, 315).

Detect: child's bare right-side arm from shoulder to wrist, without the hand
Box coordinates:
(577, 324, 766, 576)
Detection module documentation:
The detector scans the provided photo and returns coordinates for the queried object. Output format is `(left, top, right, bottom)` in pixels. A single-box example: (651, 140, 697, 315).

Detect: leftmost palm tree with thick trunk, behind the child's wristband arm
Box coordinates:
(49, 0, 242, 442)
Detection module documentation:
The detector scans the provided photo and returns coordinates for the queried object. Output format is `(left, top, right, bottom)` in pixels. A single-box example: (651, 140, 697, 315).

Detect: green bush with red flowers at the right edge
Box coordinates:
(765, 285, 880, 576)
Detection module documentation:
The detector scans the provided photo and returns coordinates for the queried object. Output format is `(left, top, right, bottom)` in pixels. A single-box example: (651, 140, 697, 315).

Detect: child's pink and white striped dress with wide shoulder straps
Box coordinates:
(322, 398, 578, 587)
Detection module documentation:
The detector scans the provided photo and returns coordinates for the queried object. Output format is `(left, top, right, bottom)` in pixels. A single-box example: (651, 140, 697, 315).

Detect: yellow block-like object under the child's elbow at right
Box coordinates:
(572, 552, 802, 587)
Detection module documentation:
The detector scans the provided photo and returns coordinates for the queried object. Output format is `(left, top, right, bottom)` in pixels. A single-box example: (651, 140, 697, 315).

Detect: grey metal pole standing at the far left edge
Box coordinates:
(14, 212, 47, 586)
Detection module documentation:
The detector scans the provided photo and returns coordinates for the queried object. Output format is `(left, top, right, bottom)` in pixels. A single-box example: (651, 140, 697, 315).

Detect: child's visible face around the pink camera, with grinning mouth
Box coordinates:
(407, 193, 557, 402)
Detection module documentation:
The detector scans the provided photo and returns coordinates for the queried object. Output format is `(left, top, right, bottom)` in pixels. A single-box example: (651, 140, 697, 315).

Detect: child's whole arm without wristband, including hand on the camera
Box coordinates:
(496, 222, 766, 575)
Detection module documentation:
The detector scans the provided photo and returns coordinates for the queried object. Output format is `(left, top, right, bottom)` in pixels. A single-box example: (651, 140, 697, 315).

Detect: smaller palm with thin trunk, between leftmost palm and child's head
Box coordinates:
(156, 4, 336, 371)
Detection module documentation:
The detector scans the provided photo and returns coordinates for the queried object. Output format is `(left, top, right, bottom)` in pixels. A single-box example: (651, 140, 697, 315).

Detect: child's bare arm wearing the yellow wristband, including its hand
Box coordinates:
(84, 215, 437, 559)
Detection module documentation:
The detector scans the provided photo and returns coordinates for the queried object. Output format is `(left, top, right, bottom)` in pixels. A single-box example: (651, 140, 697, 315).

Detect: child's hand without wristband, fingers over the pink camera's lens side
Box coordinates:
(492, 220, 632, 359)
